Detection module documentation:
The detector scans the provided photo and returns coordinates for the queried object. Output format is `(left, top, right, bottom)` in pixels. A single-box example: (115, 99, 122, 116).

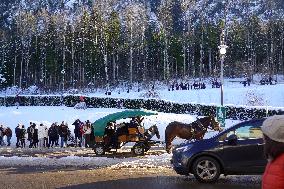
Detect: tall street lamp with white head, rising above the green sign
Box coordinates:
(219, 30, 228, 106)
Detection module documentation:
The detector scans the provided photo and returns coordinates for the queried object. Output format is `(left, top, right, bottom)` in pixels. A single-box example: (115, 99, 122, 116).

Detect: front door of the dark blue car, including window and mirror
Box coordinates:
(221, 122, 266, 174)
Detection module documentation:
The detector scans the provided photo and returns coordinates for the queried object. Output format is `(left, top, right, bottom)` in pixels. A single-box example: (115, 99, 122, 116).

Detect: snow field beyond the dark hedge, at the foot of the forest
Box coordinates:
(71, 80, 284, 109)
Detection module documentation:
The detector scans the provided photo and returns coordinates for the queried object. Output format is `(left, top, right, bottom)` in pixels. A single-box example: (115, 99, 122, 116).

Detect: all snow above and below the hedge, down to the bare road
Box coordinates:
(0, 81, 284, 167)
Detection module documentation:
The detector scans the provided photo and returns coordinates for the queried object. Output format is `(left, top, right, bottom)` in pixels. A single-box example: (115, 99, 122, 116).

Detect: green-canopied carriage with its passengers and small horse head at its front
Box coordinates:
(92, 110, 160, 155)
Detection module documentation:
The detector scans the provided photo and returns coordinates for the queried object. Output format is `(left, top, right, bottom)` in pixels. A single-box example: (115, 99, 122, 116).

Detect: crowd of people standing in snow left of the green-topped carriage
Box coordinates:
(0, 119, 93, 148)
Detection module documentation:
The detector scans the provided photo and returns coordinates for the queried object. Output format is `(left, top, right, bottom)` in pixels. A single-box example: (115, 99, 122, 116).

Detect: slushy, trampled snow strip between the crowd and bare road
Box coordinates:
(0, 148, 171, 168)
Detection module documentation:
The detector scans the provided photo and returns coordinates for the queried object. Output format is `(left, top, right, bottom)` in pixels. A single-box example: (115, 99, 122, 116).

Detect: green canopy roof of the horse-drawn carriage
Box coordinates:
(92, 109, 158, 136)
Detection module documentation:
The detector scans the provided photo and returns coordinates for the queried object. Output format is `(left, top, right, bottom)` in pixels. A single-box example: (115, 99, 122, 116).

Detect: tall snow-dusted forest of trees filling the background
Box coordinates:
(0, 0, 284, 89)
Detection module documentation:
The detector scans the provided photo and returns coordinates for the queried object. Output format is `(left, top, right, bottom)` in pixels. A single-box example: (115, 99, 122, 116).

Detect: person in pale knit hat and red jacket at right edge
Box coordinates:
(261, 115, 284, 189)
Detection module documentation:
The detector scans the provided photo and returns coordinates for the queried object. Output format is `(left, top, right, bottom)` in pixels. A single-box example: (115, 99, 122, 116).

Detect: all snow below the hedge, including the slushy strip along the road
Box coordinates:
(0, 107, 238, 167)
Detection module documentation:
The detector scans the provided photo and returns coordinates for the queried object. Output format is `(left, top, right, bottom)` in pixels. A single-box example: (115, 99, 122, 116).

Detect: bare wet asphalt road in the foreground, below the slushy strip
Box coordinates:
(0, 167, 261, 189)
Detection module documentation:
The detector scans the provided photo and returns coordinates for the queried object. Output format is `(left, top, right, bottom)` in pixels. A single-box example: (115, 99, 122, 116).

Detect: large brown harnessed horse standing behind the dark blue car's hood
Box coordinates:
(165, 116, 222, 153)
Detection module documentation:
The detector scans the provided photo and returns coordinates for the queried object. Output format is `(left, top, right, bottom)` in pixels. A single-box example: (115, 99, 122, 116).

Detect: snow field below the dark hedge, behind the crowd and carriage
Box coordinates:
(0, 106, 238, 142)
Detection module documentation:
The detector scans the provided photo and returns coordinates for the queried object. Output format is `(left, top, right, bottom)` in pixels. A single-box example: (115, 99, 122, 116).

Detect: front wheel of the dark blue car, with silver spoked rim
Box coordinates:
(192, 157, 220, 183)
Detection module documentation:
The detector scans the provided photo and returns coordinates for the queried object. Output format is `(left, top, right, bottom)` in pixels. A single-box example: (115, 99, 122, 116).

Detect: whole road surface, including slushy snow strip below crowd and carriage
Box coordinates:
(0, 147, 261, 189)
